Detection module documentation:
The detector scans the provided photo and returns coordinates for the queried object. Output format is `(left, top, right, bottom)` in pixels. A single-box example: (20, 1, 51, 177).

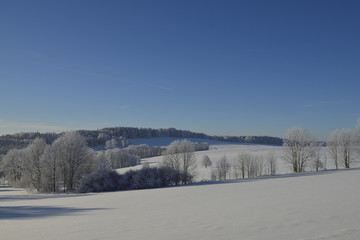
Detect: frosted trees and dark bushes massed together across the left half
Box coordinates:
(0, 132, 209, 192)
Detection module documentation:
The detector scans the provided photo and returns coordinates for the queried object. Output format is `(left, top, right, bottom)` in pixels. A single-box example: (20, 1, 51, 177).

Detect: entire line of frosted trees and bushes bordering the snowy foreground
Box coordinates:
(0, 126, 360, 192)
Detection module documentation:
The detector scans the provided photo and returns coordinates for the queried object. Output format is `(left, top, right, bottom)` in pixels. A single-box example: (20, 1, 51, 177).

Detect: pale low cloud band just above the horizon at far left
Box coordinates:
(0, 119, 74, 134)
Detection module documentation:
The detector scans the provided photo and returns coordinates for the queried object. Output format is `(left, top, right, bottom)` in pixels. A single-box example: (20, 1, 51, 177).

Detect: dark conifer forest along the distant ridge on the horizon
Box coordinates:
(0, 127, 283, 154)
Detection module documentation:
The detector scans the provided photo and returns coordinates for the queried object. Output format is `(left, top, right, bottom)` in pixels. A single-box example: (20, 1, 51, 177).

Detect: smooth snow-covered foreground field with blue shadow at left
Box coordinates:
(0, 169, 360, 240)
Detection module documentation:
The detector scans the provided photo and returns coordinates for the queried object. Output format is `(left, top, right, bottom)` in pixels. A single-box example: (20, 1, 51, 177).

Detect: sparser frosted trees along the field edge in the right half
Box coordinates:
(201, 125, 360, 181)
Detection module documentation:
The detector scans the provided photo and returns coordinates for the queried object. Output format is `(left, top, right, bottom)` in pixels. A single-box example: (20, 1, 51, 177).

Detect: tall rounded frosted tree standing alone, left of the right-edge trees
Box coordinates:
(284, 127, 314, 172)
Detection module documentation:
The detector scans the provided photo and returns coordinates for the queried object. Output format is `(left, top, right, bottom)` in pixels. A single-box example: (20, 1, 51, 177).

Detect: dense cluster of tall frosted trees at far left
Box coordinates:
(0, 132, 95, 192)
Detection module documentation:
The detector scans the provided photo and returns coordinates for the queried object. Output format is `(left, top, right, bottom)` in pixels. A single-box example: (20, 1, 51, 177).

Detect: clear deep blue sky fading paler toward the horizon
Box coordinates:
(0, 0, 360, 139)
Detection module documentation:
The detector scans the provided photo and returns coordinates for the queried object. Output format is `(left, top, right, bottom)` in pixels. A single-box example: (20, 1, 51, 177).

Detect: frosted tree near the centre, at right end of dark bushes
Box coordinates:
(161, 139, 196, 184)
